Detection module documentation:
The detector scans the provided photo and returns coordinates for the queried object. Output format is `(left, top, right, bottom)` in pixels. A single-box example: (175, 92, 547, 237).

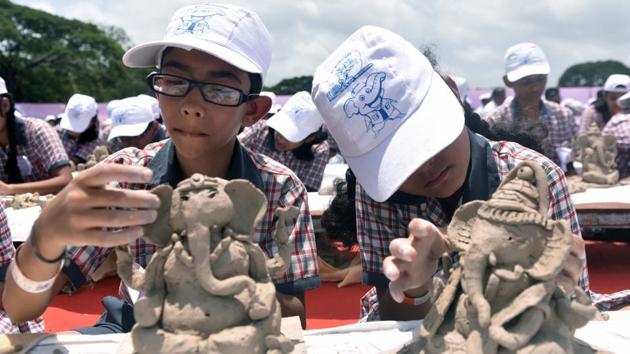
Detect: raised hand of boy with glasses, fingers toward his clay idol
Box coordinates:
(34, 164, 160, 254)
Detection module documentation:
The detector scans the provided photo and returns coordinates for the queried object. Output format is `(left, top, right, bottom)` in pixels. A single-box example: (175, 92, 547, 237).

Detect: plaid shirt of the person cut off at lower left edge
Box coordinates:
(0, 202, 44, 334)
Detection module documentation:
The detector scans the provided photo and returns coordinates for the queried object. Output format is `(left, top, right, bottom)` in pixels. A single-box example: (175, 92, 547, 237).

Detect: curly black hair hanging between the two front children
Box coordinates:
(320, 169, 357, 247)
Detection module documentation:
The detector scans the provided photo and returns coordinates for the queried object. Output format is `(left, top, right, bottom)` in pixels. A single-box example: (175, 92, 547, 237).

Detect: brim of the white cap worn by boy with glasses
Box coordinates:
(123, 36, 263, 75)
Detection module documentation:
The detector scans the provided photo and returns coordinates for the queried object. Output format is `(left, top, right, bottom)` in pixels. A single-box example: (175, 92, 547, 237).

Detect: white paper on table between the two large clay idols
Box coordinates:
(304, 321, 422, 354)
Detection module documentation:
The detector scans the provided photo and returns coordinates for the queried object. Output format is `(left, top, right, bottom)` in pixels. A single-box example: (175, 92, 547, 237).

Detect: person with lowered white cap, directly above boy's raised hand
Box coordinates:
(55, 93, 103, 163)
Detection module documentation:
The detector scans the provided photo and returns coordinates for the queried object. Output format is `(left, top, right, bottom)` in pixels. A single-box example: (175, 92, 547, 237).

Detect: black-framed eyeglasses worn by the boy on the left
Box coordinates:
(146, 72, 258, 107)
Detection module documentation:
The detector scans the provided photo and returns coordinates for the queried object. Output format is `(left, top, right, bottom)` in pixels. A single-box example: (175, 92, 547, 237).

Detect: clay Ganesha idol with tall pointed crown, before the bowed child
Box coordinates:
(400, 162, 604, 353)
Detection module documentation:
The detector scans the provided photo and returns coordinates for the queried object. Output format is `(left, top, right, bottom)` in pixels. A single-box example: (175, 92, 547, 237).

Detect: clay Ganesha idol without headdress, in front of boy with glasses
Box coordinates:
(116, 174, 297, 354)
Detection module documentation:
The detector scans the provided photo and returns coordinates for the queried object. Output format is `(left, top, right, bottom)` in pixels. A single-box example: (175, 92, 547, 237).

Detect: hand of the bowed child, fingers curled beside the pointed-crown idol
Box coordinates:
(383, 219, 449, 302)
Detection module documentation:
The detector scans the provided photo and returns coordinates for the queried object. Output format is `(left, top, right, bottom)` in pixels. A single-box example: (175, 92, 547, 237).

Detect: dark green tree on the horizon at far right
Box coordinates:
(558, 60, 630, 87)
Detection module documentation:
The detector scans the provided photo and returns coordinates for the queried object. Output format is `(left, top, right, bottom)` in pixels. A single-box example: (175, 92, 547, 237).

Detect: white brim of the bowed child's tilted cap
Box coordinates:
(342, 73, 464, 202)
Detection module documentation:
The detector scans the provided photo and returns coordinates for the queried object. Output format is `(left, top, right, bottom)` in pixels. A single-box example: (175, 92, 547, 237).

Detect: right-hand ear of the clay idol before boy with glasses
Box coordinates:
(225, 179, 267, 235)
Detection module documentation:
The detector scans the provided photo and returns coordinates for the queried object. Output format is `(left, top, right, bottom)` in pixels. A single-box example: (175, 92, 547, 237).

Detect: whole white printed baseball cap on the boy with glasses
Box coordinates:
(123, 4, 271, 81)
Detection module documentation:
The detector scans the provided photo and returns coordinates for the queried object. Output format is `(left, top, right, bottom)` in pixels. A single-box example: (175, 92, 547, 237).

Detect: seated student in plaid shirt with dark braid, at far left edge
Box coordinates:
(0, 78, 72, 194)
